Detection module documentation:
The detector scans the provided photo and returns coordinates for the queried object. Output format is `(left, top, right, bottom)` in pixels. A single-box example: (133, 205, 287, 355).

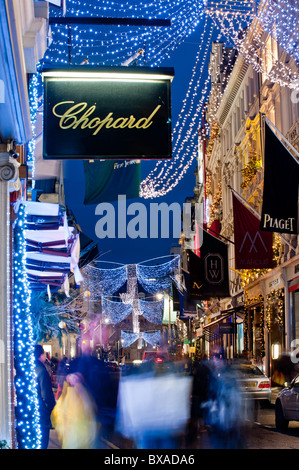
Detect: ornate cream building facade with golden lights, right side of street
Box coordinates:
(202, 19, 299, 376)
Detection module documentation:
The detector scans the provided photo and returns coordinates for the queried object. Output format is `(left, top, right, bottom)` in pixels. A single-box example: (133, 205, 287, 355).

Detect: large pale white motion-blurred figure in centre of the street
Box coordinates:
(116, 361, 192, 449)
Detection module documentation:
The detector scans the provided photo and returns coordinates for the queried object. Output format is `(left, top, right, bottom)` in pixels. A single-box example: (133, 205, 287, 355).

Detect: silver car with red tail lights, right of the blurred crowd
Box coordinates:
(233, 363, 271, 402)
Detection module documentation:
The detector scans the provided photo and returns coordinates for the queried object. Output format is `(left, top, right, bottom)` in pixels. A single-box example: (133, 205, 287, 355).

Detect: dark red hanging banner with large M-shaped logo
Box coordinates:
(232, 194, 273, 269)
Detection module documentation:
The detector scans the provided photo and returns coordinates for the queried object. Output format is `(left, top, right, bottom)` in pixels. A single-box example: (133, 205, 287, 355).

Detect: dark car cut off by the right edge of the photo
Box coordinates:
(275, 375, 299, 429)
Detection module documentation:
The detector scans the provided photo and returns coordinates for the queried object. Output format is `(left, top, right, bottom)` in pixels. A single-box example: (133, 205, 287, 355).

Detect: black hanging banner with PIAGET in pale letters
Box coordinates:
(260, 123, 299, 234)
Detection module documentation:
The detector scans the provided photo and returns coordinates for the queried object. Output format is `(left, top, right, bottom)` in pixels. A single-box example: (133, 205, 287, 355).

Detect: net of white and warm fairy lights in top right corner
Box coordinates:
(207, 0, 299, 89)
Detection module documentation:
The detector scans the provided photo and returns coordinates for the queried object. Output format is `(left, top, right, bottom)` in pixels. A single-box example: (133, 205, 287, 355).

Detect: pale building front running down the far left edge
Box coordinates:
(0, 0, 49, 447)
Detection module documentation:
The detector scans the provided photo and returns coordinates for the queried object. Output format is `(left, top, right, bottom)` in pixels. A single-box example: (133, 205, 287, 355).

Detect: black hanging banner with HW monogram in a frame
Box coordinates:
(187, 230, 230, 300)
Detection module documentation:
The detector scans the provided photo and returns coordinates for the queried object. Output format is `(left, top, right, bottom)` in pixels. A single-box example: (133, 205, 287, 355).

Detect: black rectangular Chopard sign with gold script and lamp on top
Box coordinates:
(43, 66, 174, 160)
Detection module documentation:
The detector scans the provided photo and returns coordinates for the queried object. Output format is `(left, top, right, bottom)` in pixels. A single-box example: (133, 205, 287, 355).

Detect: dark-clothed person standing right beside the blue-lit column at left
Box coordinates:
(34, 344, 55, 449)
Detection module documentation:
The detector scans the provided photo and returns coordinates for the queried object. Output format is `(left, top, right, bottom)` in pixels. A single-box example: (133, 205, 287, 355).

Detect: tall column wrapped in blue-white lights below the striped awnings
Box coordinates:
(13, 204, 41, 449)
